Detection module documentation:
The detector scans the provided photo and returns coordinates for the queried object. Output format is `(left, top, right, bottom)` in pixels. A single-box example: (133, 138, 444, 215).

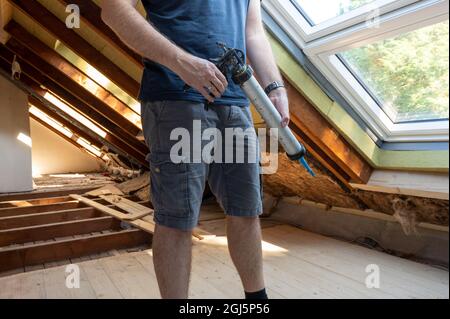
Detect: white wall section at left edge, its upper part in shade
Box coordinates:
(0, 75, 33, 193)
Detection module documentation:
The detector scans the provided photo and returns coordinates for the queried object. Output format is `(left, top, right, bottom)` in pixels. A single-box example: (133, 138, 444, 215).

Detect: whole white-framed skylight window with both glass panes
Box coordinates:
(263, 0, 449, 142)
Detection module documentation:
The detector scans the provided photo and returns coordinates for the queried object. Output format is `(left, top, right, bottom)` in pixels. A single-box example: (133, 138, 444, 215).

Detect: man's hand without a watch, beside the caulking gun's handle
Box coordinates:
(173, 52, 228, 102)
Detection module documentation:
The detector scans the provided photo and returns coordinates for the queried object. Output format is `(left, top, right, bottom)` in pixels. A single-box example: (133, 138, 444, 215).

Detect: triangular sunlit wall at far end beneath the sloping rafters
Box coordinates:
(30, 119, 101, 176)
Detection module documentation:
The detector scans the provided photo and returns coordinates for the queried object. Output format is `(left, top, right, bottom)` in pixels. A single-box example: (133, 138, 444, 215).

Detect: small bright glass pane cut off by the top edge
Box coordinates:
(292, 0, 376, 25)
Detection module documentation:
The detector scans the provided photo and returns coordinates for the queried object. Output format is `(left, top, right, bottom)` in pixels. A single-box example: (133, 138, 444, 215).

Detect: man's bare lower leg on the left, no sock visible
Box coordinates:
(153, 225, 192, 299)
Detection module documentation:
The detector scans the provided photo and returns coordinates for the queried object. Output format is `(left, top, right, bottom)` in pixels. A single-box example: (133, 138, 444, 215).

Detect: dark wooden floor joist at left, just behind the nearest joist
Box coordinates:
(0, 216, 120, 247)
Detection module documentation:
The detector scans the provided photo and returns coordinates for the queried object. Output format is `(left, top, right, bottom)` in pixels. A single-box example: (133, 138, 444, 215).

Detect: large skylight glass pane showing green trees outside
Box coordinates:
(340, 21, 449, 123)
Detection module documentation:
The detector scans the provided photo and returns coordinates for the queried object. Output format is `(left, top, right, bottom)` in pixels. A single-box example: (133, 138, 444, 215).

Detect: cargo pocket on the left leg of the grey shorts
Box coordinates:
(147, 153, 191, 218)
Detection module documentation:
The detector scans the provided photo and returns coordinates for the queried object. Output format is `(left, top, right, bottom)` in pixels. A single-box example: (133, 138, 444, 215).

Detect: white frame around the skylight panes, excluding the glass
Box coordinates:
(263, 0, 449, 142)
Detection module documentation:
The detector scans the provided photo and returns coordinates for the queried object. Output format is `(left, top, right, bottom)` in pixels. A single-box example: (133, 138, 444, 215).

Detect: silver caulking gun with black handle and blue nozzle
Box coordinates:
(211, 43, 315, 176)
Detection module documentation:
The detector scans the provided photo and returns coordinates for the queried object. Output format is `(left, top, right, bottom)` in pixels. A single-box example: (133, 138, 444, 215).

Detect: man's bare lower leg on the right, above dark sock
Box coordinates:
(227, 216, 265, 293)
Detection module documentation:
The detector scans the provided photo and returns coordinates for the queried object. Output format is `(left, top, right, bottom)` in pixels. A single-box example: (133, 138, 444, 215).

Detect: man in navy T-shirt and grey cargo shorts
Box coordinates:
(102, 0, 289, 299)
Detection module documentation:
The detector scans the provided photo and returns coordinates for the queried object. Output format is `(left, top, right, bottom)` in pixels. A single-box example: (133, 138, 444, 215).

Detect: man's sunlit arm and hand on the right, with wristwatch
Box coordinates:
(246, 0, 289, 126)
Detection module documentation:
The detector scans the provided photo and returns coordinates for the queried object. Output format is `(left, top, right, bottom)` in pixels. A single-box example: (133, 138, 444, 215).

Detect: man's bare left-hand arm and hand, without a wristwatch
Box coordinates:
(101, 0, 228, 102)
